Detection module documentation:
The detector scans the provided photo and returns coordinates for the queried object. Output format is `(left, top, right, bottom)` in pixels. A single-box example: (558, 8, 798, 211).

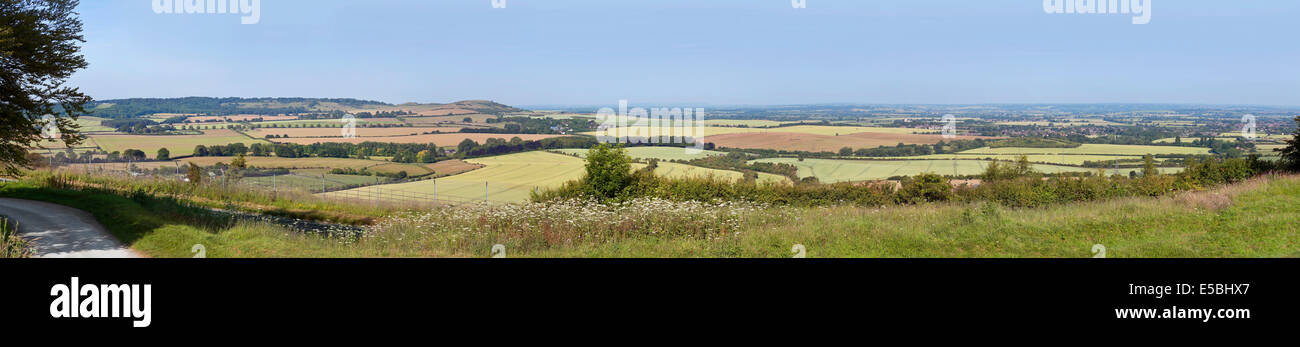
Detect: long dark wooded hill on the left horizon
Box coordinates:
(87, 96, 524, 118)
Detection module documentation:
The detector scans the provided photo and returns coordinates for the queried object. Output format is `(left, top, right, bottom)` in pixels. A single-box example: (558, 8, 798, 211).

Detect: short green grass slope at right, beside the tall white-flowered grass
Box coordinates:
(543, 177, 1300, 257)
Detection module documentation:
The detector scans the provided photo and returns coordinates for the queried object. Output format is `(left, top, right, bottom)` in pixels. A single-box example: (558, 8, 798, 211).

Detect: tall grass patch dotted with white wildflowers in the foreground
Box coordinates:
(359, 198, 796, 256)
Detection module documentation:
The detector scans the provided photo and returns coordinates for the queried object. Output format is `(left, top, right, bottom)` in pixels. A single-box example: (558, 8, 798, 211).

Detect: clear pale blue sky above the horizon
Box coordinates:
(73, 0, 1300, 105)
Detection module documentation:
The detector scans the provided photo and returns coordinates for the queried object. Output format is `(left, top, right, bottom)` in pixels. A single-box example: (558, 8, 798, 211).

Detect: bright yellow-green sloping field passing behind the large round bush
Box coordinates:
(330, 151, 787, 203)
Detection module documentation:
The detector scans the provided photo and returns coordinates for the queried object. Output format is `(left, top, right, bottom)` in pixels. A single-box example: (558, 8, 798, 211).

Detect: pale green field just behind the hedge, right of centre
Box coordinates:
(755, 157, 1092, 183)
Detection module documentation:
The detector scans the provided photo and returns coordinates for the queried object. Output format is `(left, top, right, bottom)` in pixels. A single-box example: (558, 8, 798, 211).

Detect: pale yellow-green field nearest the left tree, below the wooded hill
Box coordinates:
(90, 130, 268, 157)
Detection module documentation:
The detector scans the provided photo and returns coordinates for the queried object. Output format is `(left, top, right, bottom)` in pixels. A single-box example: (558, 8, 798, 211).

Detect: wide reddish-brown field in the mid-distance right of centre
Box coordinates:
(705, 133, 995, 152)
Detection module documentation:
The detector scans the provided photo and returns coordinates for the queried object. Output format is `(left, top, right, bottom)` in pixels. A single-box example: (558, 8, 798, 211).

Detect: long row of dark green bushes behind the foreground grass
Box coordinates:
(533, 144, 1277, 207)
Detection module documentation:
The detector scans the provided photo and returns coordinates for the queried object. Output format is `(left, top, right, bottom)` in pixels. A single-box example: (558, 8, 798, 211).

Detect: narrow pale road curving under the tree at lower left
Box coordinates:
(0, 199, 140, 257)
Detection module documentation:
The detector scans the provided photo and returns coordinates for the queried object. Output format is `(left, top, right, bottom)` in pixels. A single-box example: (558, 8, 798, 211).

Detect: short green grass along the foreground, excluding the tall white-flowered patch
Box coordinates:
(0, 177, 1300, 257)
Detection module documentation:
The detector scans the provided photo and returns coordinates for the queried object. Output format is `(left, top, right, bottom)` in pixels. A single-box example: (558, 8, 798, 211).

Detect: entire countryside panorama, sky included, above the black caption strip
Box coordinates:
(0, 0, 1300, 259)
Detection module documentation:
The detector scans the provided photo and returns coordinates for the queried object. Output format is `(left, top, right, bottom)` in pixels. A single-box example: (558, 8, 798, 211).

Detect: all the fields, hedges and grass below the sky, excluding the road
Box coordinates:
(0, 97, 1300, 257)
